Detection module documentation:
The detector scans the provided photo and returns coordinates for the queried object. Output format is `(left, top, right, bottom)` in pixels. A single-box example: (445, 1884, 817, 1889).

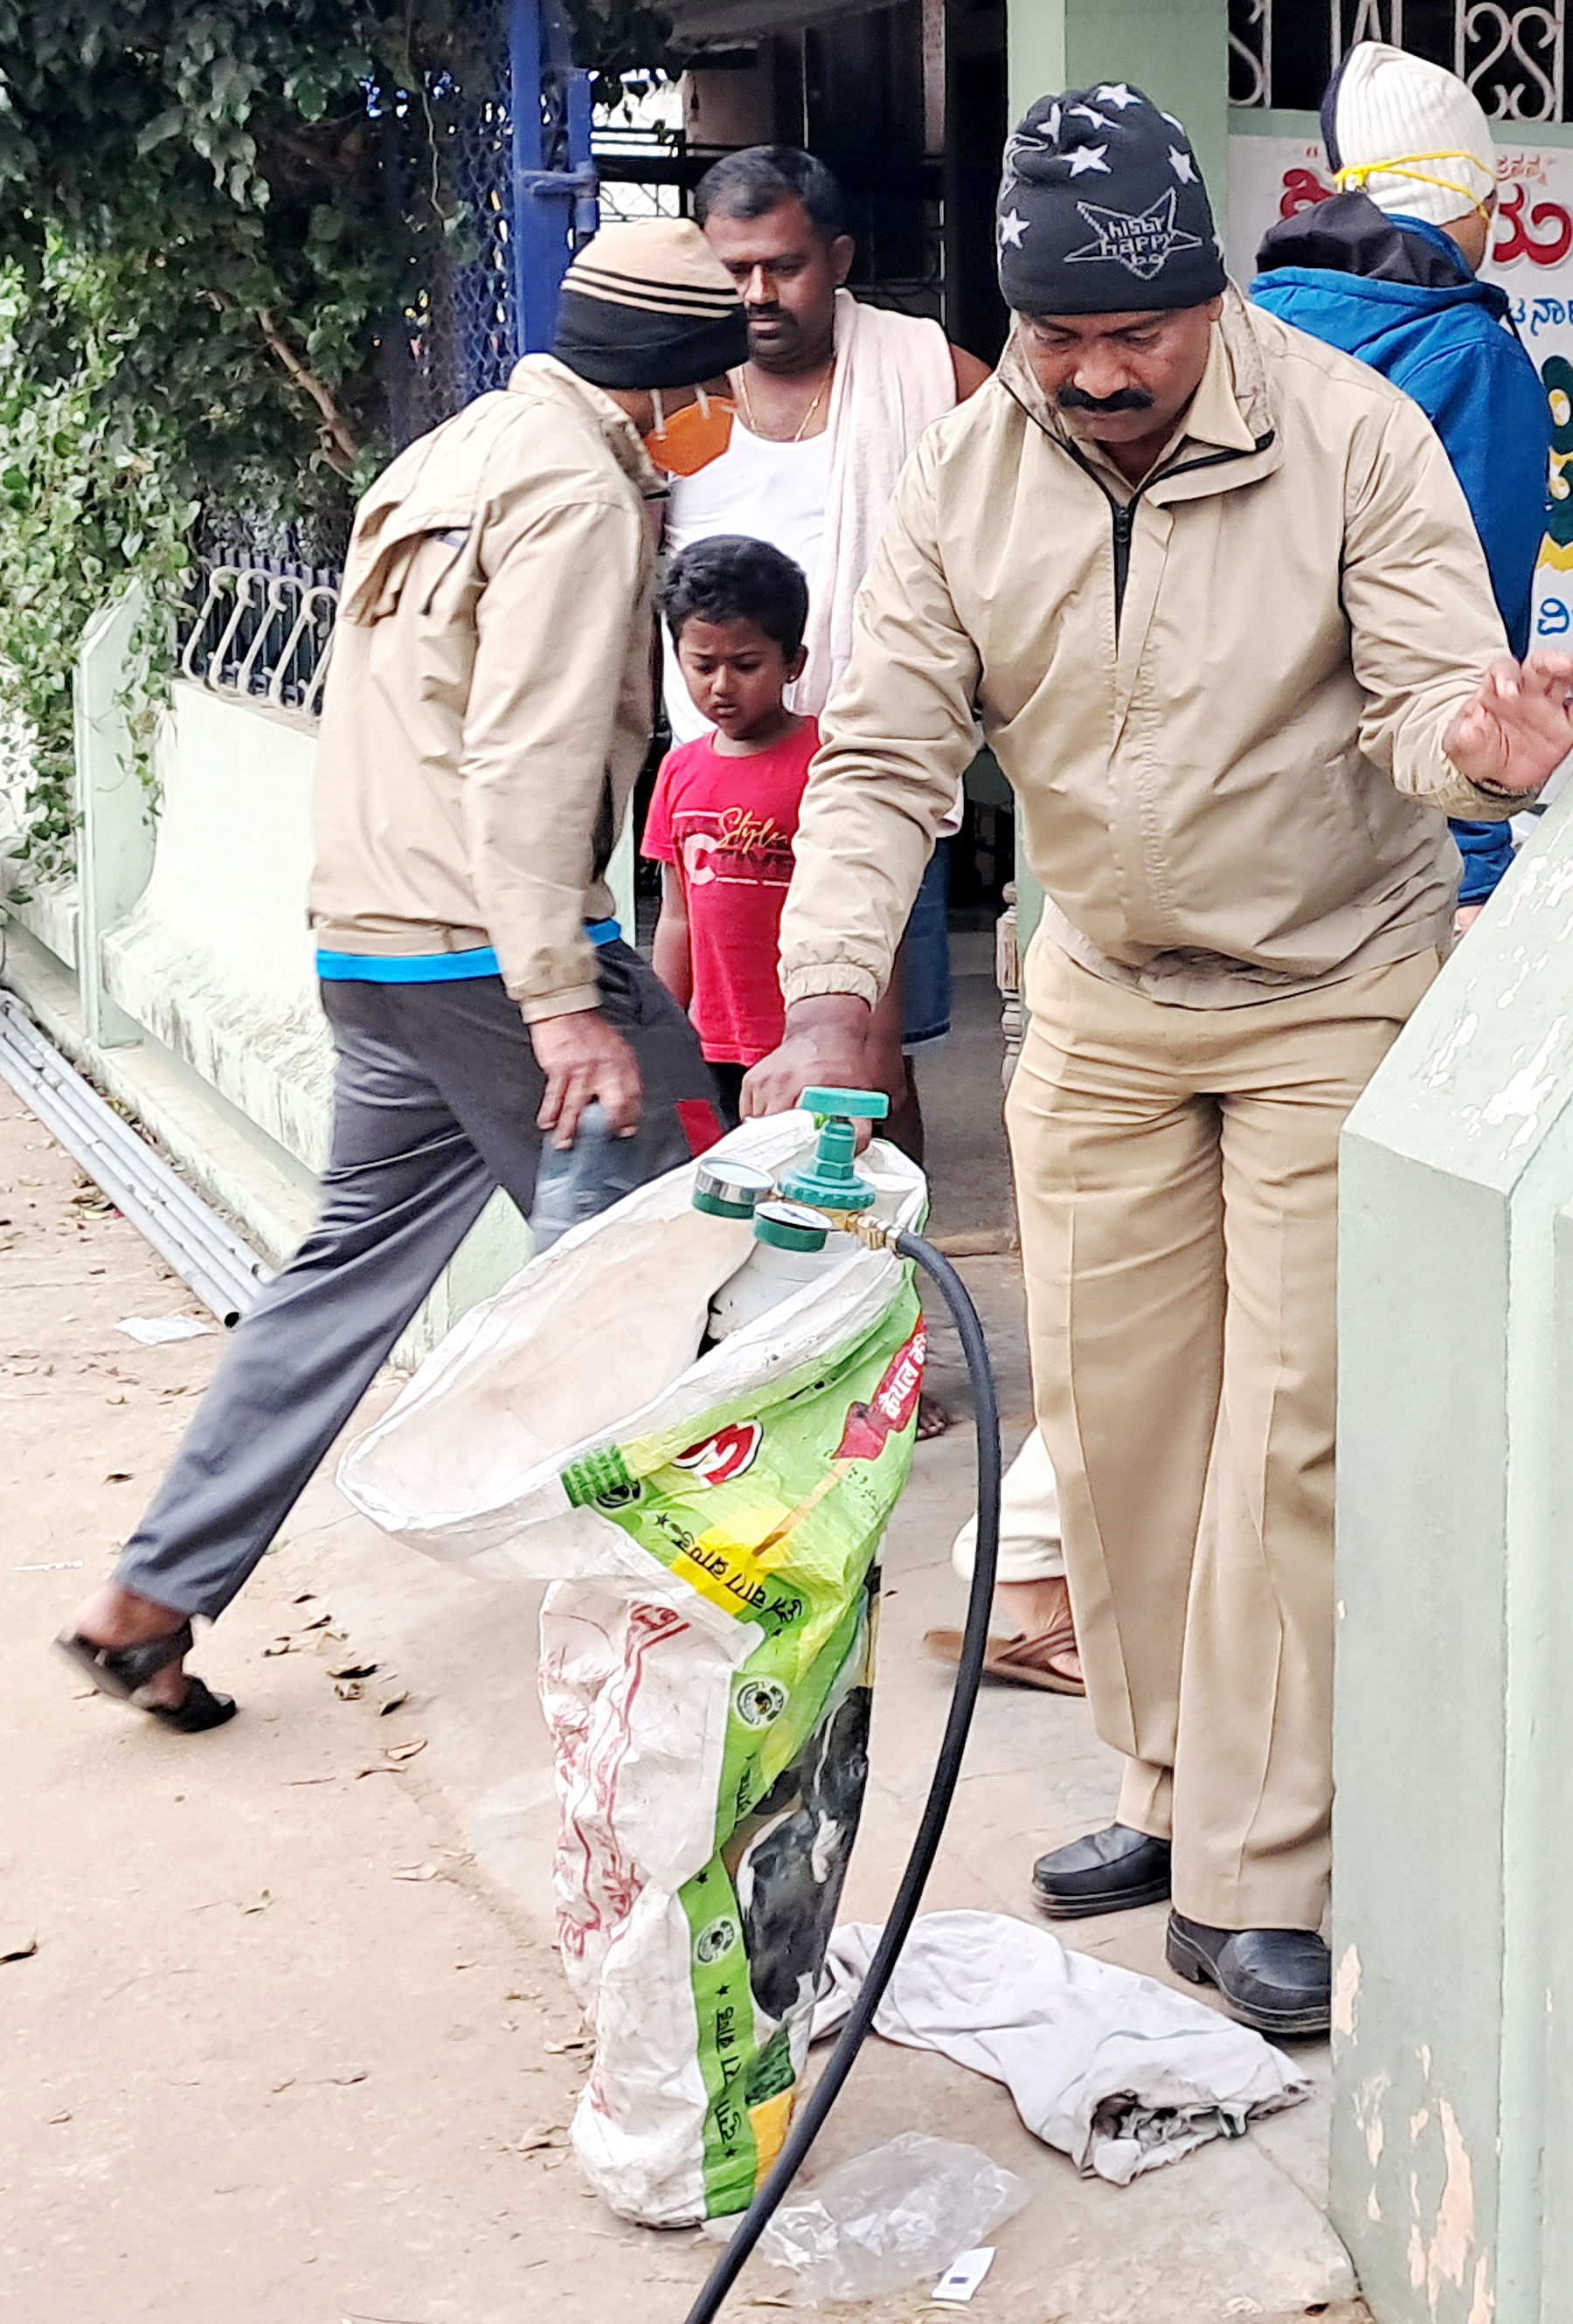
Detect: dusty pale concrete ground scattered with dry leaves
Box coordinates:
(0, 1085, 1364, 2324)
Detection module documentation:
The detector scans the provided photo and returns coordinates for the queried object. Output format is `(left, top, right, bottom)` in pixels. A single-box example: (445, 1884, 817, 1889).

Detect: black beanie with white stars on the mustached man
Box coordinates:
(999, 81, 1227, 314)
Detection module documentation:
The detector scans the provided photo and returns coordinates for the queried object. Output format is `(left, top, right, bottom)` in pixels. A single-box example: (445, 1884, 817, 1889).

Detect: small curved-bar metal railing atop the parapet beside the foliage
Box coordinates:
(179, 564, 339, 718)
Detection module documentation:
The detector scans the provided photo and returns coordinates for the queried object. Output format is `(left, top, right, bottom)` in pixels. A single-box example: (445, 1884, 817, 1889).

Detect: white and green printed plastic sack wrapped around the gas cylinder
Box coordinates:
(339, 1113, 927, 2226)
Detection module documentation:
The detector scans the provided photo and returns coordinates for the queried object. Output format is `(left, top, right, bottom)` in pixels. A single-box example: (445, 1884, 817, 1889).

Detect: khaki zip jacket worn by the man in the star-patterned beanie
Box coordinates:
(780, 291, 1506, 1008)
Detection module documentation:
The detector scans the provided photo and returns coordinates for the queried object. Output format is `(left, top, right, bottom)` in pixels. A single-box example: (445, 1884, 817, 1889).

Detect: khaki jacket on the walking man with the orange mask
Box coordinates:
(309, 356, 664, 1020)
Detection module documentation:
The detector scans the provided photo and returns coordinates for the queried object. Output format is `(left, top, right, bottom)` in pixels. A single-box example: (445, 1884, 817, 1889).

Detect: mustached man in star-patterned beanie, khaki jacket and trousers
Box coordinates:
(745, 81, 1573, 2034)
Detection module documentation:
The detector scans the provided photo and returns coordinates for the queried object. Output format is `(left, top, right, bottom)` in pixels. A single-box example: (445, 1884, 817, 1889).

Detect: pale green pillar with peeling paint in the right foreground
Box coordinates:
(1331, 802, 1573, 2324)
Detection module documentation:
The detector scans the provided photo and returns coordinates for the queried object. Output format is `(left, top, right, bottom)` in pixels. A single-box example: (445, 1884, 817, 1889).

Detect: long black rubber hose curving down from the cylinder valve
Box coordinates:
(688, 1234, 1001, 2324)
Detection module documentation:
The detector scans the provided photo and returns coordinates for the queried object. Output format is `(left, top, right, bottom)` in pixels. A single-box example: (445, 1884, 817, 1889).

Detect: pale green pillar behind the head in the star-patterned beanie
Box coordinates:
(1006, 0, 1229, 951)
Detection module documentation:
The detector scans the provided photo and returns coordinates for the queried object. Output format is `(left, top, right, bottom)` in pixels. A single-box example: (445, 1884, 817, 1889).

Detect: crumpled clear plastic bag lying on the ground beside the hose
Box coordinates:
(759, 2131, 1027, 2307)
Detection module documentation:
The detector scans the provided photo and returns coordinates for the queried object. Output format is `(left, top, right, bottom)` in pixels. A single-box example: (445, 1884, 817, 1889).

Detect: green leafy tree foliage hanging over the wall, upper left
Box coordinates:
(0, 0, 664, 865)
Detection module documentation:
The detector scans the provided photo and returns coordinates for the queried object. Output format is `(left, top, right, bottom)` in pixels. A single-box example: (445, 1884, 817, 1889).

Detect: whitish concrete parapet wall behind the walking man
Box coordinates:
(7, 608, 558, 1362)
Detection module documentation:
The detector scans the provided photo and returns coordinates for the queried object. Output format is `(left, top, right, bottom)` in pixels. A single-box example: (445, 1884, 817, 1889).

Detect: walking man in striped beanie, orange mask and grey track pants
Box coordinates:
(60, 221, 748, 1733)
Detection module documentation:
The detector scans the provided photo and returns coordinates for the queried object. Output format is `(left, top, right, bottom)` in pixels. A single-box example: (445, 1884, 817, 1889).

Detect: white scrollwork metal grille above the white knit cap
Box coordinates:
(1229, 0, 1573, 121)
